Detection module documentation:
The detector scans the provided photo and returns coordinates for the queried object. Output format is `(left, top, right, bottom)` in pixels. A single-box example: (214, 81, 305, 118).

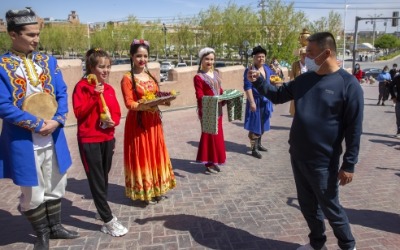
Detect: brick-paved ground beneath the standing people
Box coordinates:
(0, 84, 400, 250)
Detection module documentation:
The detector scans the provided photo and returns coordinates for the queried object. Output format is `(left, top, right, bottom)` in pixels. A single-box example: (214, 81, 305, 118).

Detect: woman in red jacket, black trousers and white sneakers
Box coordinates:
(72, 49, 128, 237)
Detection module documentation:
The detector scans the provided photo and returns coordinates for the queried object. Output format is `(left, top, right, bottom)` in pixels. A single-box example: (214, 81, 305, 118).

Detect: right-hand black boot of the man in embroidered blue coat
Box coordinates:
(46, 199, 79, 239)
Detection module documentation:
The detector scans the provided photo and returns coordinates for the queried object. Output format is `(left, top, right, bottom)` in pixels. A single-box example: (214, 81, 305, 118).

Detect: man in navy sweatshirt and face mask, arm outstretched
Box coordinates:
(247, 32, 364, 250)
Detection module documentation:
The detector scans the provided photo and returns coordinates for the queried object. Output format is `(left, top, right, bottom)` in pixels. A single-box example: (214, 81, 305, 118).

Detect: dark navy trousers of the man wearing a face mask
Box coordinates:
(291, 157, 356, 250)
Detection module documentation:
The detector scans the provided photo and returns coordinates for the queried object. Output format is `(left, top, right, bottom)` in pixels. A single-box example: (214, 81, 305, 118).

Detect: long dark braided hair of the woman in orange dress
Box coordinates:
(129, 39, 159, 129)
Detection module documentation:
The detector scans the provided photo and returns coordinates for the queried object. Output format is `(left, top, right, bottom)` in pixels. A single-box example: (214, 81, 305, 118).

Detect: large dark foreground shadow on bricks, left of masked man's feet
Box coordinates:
(135, 214, 299, 250)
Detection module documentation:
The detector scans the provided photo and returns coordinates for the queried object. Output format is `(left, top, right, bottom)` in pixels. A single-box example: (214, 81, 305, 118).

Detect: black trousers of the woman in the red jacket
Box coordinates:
(79, 139, 115, 223)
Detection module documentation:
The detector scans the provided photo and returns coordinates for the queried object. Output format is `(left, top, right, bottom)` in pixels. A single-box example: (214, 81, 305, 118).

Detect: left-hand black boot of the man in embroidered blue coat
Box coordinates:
(23, 203, 50, 250)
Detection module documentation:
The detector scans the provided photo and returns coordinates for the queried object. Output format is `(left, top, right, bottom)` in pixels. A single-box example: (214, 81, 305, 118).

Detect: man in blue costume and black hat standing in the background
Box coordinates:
(243, 46, 275, 159)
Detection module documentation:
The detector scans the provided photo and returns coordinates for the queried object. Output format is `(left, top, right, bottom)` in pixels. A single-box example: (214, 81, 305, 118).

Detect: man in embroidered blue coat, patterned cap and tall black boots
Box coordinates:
(0, 8, 79, 249)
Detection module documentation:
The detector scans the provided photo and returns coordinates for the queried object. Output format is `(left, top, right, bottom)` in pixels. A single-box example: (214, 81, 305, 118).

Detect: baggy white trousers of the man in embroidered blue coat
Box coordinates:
(20, 146, 67, 212)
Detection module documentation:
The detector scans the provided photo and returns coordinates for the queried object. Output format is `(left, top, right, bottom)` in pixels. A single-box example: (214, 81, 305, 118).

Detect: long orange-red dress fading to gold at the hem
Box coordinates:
(121, 73, 176, 201)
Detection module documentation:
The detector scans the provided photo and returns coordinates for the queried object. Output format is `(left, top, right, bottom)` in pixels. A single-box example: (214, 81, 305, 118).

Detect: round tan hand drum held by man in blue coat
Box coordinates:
(22, 93, 58, 120)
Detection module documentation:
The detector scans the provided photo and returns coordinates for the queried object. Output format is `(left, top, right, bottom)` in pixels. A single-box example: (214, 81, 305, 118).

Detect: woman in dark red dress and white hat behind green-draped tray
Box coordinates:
(193, 48, 226, 174)
